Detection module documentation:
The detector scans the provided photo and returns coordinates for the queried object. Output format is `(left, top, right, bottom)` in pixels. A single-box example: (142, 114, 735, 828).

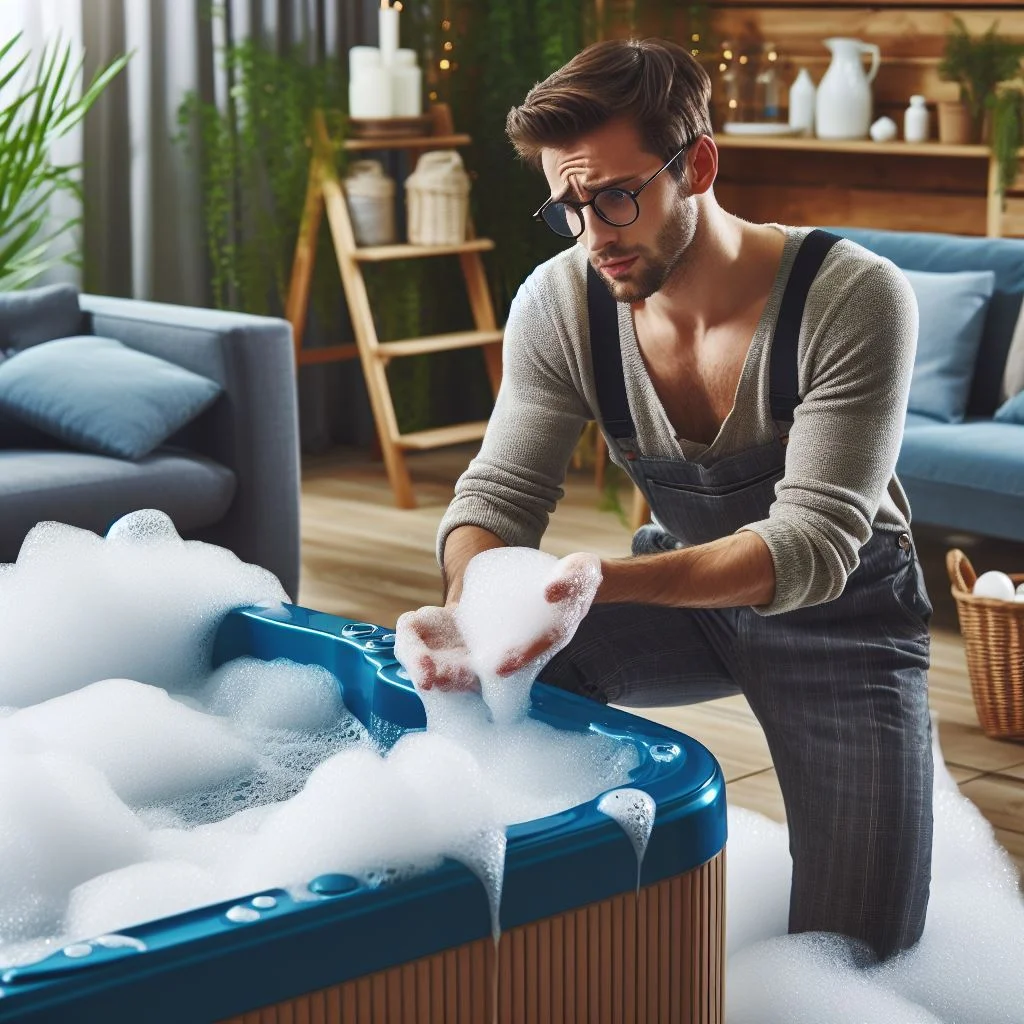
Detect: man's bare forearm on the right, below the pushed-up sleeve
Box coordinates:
(598, 530, 775, 608)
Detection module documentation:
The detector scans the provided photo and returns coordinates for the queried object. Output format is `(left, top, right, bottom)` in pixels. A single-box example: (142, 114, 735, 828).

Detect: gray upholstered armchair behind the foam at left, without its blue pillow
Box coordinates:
(0, 292, 299, 600)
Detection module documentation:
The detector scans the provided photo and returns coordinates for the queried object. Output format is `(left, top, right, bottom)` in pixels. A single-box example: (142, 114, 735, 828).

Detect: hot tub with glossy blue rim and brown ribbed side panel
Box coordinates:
(0, 606, 726, 1024)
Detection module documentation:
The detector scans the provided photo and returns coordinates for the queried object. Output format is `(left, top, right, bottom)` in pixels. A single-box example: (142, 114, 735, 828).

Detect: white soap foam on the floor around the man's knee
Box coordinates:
(726, 730, 1024, 1024)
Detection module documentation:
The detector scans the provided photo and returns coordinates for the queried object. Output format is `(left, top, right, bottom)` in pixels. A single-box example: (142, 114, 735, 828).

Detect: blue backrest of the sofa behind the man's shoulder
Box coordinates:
(828, 227, 1024, 418)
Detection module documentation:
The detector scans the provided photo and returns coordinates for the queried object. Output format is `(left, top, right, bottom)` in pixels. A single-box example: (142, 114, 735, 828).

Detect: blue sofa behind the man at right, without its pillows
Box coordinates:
(829, 227, 1024, 542)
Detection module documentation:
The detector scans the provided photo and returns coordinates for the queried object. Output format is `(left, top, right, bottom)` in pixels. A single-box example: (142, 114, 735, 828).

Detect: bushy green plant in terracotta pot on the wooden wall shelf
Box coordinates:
(939, 17, 1024, 142)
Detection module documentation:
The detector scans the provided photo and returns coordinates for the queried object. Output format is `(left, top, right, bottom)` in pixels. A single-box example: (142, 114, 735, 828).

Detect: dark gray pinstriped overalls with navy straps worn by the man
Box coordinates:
(543, 230, 932, 956)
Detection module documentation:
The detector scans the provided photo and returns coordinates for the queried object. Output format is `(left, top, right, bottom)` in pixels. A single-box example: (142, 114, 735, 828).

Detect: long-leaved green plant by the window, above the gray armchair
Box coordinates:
(0, 33, 128, 291)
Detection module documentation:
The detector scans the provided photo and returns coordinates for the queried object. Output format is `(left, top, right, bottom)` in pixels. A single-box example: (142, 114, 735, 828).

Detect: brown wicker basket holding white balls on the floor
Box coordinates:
(946, 549, 1024, 740)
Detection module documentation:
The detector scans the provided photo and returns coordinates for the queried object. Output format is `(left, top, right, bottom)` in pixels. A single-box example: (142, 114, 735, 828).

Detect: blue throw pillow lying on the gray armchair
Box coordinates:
(0, 335, 223, 459)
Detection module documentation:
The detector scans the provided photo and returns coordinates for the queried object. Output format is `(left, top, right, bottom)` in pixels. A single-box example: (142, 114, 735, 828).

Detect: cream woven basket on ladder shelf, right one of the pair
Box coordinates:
(406, 150, 469, 246)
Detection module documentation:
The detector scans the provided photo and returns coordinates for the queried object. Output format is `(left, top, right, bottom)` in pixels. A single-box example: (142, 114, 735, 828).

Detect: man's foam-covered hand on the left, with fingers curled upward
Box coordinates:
(394, 605, 480, 691)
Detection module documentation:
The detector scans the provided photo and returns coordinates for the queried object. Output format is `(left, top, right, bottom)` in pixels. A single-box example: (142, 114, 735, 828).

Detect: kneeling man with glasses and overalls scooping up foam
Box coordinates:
(399, 34, 932, 956)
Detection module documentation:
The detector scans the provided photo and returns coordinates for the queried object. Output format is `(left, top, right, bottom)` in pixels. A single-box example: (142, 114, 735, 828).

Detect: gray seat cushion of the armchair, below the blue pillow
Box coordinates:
(0, 449, 236, 562)
